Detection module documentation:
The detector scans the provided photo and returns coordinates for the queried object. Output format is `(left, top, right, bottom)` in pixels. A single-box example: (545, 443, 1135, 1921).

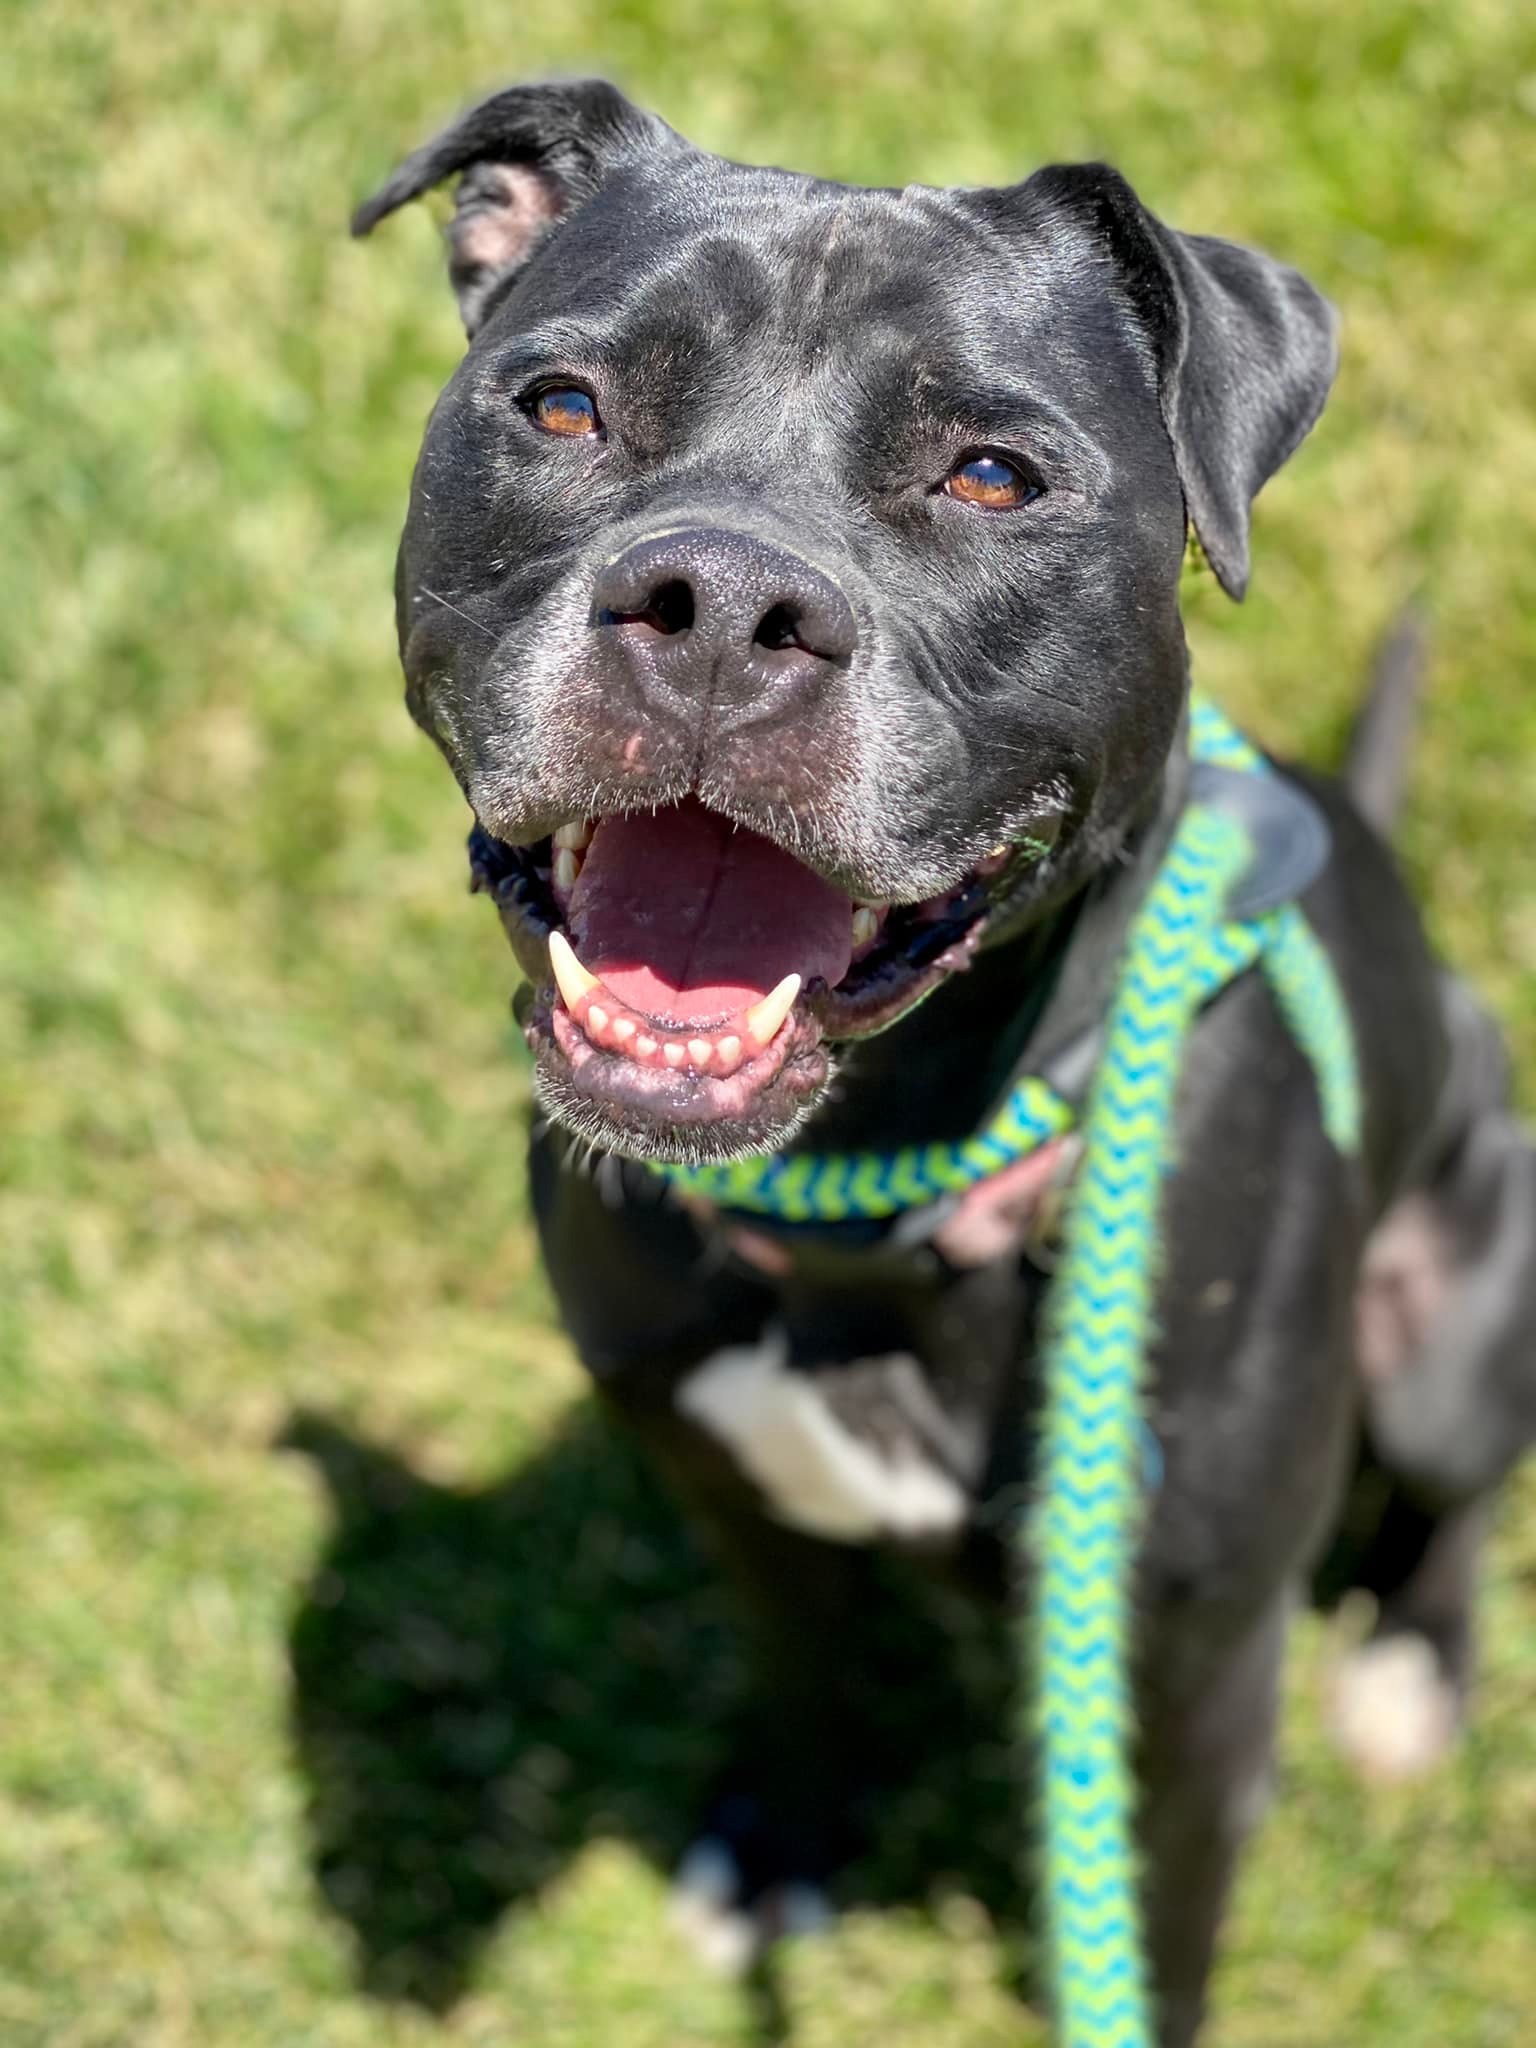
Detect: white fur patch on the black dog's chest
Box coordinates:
(678, 1331, 967, 1542)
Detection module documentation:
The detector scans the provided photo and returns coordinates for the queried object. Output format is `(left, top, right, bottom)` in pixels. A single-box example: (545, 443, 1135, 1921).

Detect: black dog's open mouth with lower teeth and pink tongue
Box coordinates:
(469, 799, 1012, 1159)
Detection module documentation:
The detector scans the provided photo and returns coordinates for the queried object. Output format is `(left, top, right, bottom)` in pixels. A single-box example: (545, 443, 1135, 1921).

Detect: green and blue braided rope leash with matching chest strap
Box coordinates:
(657, 700, 1360, 2048)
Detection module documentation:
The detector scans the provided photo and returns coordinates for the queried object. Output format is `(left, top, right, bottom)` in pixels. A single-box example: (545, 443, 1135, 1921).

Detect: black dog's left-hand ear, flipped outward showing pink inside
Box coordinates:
(352, 78, 678, 336)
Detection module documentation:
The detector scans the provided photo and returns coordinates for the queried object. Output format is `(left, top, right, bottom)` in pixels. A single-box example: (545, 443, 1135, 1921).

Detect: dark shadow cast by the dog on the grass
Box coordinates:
(283, 1407, 1016, 2038)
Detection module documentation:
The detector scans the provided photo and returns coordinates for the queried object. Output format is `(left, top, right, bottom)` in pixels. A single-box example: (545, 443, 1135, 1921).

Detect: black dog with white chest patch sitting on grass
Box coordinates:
(354, 84, 1536, 2048)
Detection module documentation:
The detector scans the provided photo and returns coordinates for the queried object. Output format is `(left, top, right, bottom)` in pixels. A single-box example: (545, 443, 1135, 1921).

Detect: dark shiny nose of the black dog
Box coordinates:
(594, 526, 858, 711)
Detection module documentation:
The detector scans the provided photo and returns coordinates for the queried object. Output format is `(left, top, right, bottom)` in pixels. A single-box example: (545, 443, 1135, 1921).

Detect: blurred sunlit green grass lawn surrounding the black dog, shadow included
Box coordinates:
(0, 0, 1536, 2048)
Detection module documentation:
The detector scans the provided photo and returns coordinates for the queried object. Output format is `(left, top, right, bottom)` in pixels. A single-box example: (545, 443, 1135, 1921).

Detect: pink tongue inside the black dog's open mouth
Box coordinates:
(569, 799, 852, 1024)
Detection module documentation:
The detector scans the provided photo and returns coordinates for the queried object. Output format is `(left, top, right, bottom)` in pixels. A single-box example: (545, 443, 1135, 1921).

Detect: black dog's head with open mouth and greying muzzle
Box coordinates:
(354, 82, 1333, 1159)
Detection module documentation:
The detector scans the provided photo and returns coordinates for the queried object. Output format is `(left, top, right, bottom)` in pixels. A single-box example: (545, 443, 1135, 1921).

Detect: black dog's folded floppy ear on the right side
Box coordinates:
(1026, 164, 1337, 598)
